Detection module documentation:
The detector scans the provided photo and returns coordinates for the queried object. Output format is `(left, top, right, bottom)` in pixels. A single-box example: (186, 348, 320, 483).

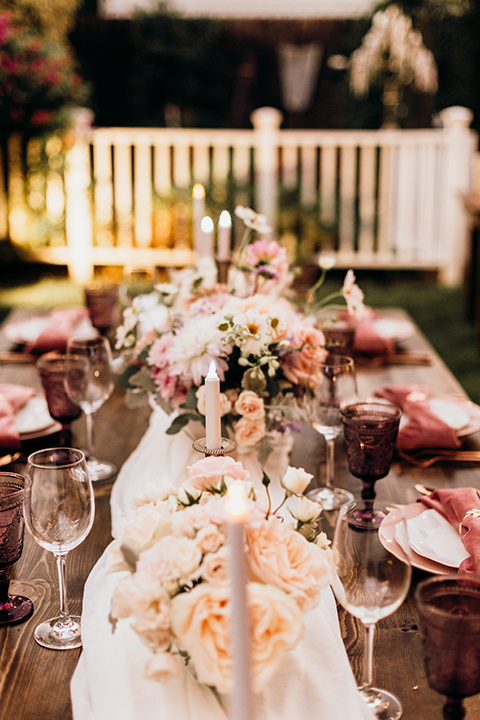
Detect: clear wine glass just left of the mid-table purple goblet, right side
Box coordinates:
(304, 355, 357, 510)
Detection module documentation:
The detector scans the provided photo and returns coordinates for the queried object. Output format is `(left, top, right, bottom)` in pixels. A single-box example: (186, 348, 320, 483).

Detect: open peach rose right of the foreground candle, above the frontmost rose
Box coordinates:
(247, 517, 330, 612)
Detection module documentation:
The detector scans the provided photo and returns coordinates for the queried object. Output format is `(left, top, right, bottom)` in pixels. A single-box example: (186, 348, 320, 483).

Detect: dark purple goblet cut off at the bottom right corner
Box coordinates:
(415, 574, 480, 720)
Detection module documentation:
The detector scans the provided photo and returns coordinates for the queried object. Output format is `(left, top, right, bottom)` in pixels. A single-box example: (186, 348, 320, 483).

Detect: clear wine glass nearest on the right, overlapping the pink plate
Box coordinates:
(332, 503, 412, 720)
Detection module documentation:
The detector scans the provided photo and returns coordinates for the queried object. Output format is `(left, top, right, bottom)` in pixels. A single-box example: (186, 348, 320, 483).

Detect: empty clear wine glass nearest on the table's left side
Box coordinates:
(25, 448, 95, 650)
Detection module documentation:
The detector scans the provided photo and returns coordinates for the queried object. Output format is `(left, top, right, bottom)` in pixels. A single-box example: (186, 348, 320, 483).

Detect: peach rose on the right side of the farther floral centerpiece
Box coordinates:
(282, 320, 327, 387)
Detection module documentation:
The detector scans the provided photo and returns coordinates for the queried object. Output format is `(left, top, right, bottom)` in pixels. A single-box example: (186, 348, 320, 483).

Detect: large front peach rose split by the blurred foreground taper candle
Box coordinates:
(172, 583, 303, 693)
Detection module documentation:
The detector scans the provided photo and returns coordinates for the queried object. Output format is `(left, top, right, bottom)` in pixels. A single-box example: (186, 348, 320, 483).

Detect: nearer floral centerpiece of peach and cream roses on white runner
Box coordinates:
(109, 456, 332, 693)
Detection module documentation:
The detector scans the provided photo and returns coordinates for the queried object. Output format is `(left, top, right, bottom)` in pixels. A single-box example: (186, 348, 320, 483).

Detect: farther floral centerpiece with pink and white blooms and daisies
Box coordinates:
(116, 208, 363, 457)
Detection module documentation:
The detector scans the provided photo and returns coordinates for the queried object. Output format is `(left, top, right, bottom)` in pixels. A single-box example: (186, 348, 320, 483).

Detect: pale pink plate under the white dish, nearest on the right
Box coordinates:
(378, 502, 464, 575)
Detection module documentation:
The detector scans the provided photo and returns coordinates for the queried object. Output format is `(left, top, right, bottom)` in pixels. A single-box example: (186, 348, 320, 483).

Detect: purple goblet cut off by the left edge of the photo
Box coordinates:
(0, 472, 33, 625)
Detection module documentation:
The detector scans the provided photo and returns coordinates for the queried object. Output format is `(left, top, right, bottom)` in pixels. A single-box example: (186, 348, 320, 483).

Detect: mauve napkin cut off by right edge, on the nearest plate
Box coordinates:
(419, 487, 480, 573)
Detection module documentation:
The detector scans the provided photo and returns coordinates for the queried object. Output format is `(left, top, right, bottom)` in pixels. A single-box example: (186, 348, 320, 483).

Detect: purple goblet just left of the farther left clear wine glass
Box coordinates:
(36, 353, 82, 445)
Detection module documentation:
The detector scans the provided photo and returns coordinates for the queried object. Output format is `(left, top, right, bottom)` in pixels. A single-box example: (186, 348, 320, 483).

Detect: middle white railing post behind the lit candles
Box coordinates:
(250, 107, 283, 228)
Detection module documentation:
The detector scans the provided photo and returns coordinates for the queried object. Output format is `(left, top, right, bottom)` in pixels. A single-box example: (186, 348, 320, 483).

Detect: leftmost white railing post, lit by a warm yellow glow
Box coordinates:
(65, 108, 94, 285)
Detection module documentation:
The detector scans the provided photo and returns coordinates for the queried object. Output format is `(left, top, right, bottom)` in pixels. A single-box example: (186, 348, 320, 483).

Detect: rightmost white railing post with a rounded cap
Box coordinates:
(440, 106, 474, 285)
